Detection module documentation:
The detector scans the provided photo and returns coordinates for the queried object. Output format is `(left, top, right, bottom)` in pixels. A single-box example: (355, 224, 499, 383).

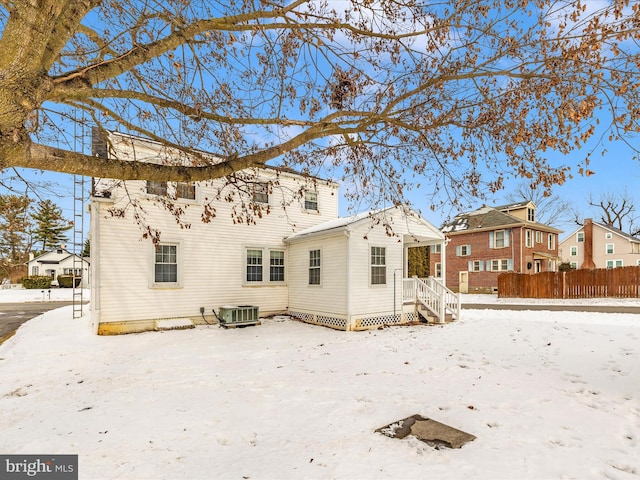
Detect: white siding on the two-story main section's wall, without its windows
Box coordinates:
(93, 167, 338, 322)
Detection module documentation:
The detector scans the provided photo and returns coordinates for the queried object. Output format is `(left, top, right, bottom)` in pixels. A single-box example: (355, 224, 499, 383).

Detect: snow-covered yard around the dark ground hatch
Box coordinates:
(0, 291, 640, 480)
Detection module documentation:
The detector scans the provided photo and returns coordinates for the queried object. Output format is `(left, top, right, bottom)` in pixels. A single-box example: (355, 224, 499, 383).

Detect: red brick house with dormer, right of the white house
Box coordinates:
(430, 202, 561, 293)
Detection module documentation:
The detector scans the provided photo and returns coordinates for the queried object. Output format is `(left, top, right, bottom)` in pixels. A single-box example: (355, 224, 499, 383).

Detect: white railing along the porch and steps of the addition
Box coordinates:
(402, 277, 460, 323)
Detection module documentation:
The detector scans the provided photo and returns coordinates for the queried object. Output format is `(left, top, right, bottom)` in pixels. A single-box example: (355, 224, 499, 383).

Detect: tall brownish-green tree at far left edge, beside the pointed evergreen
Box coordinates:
(0, 195, 31, 278)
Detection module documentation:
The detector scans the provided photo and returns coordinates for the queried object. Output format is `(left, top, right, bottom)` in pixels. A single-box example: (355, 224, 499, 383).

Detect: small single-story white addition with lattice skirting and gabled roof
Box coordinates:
(284, 207, 444, 330)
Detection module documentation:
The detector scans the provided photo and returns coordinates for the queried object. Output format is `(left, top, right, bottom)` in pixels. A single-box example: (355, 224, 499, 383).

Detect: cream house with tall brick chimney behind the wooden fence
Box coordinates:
(559, 218, 640, 268)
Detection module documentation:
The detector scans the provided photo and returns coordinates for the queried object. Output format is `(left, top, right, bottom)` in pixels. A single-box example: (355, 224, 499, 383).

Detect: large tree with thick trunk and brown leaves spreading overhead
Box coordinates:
(0, 0, 640, 214)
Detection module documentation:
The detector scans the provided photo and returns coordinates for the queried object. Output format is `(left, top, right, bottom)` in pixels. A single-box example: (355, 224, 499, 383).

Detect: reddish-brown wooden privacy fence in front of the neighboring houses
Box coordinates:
(498, 266, 640, 298)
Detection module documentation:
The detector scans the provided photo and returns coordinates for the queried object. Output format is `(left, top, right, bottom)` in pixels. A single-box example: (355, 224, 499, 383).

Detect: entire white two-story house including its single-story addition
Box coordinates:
(90, 130, 456, 334)
